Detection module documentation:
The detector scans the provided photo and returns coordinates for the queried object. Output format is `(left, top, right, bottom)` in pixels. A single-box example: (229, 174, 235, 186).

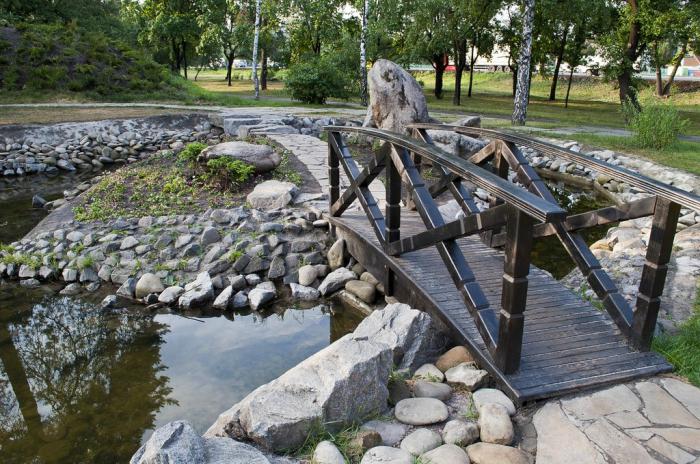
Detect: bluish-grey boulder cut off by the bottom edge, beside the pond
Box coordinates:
(129, 421, 270, 464)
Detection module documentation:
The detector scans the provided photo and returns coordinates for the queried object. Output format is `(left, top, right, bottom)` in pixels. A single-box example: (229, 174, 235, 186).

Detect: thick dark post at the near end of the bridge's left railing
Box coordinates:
(495, 205, 533, 374)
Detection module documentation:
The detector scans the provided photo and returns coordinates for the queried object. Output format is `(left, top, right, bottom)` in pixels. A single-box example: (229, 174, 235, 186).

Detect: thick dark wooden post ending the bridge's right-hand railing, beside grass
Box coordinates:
(631, 197, 681, 351)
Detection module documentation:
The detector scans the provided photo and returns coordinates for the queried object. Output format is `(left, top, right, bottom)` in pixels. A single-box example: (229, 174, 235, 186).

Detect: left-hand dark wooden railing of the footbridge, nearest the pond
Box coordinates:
(324, 126, 566, 373)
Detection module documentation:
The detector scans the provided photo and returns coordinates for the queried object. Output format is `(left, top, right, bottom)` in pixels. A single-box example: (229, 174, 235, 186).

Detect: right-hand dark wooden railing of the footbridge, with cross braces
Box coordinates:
(410, 124, 700, 351)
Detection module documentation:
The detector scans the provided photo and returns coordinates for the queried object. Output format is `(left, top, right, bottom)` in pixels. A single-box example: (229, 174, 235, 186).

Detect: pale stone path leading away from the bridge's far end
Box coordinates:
(267, 134, 386, 208)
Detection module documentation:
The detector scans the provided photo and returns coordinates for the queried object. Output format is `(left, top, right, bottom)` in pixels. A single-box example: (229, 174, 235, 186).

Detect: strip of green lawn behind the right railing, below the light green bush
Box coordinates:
(520, 131, 700, 175)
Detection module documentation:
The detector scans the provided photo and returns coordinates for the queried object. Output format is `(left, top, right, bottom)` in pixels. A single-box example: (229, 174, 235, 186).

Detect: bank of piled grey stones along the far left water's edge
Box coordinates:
(0, 115, 223, 176)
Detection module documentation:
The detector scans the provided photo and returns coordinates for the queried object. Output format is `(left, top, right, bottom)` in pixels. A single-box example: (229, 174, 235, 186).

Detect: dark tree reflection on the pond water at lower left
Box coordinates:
(0, 292, 173, 463)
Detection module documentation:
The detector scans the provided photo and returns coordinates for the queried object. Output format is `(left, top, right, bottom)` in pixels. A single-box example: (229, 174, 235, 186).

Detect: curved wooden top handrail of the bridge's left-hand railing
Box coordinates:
(323, 126, 566, 222)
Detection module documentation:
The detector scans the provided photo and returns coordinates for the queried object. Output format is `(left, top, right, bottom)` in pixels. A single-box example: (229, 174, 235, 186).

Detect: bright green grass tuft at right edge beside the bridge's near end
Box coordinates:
(653, 291, 700, 387)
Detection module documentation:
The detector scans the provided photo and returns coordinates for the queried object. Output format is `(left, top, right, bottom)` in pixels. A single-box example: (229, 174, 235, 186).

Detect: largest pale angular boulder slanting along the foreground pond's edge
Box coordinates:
(205, 334, 394, 454)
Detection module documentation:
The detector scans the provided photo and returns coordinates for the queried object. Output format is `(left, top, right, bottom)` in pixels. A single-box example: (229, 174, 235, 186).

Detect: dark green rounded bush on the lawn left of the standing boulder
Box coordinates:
(285, 57, 350, 104)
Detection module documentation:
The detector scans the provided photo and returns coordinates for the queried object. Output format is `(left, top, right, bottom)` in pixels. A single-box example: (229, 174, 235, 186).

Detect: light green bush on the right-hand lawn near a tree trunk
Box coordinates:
(622, 102, 688, 150)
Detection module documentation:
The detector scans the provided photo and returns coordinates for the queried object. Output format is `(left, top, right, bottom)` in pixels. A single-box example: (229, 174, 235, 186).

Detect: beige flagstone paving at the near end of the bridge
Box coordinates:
(533, 377, 700, 464)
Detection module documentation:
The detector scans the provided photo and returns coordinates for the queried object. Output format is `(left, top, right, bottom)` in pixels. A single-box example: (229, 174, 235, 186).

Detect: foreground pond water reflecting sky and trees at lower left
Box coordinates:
(0, 285, 362, 463)
